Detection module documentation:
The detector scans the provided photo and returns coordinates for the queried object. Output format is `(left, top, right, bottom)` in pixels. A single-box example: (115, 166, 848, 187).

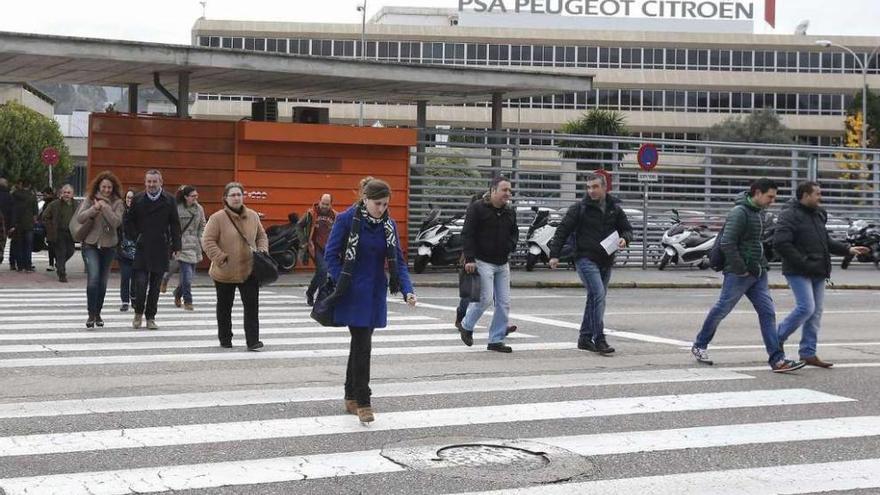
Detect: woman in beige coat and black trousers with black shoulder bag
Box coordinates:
(202, 182, 269, 351)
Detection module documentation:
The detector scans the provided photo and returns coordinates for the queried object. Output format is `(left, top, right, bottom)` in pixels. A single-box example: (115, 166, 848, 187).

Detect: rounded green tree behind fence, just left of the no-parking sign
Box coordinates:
(559, 109, 629, 171)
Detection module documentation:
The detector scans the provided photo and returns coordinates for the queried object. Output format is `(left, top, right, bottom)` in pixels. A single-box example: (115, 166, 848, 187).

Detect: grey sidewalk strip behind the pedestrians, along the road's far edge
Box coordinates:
(0, 252, 880, 291)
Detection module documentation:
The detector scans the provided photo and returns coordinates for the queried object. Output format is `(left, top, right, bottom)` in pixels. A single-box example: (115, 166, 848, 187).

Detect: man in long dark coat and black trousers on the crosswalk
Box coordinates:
(124, 170, 181, 330)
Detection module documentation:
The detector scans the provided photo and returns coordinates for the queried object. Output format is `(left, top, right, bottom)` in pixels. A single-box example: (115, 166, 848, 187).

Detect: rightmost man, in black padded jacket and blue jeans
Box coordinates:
(773, 182, 868, 368)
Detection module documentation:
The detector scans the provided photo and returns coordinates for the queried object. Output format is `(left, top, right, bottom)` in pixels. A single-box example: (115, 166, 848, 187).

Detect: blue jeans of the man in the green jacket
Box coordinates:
(694, 273, 785, 365)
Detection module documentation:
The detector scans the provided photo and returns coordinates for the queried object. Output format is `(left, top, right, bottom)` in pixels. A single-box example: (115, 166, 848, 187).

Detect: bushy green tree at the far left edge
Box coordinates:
(0, 101, 73, 187)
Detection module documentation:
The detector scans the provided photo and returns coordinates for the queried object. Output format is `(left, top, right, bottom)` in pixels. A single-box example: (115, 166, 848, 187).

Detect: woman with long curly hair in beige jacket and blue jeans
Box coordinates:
(74, 172, 125, 328)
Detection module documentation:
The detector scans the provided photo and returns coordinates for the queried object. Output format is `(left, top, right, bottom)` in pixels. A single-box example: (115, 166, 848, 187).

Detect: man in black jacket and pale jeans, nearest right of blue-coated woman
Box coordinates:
(457, 176, 519, 352)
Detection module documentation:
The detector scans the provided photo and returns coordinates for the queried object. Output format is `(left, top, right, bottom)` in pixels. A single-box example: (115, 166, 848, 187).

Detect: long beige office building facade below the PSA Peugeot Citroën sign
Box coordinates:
(192, 7, 880, 145)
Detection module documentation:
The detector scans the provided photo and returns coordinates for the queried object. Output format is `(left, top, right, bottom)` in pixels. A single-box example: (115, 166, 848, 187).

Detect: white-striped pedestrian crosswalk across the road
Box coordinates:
(0, 288, 880, 495)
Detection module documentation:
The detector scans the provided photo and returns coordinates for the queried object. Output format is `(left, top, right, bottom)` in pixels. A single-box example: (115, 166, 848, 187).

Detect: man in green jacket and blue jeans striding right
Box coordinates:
(691, 178, 805, 373)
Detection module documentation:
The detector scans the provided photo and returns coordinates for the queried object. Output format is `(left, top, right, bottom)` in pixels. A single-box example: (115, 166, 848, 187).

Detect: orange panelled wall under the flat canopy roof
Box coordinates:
(88, 114, 416, 272)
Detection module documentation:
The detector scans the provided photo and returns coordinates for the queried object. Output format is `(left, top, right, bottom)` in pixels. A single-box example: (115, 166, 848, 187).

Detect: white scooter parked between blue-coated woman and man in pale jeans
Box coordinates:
(413, 208, 464, 273)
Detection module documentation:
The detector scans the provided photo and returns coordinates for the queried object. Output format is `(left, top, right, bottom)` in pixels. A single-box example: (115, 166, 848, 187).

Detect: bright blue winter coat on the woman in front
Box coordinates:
(324, 207, 413, 328)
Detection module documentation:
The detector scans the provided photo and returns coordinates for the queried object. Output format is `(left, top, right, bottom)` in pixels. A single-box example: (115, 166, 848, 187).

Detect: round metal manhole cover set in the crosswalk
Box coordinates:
(437, 443, 550, 471)
